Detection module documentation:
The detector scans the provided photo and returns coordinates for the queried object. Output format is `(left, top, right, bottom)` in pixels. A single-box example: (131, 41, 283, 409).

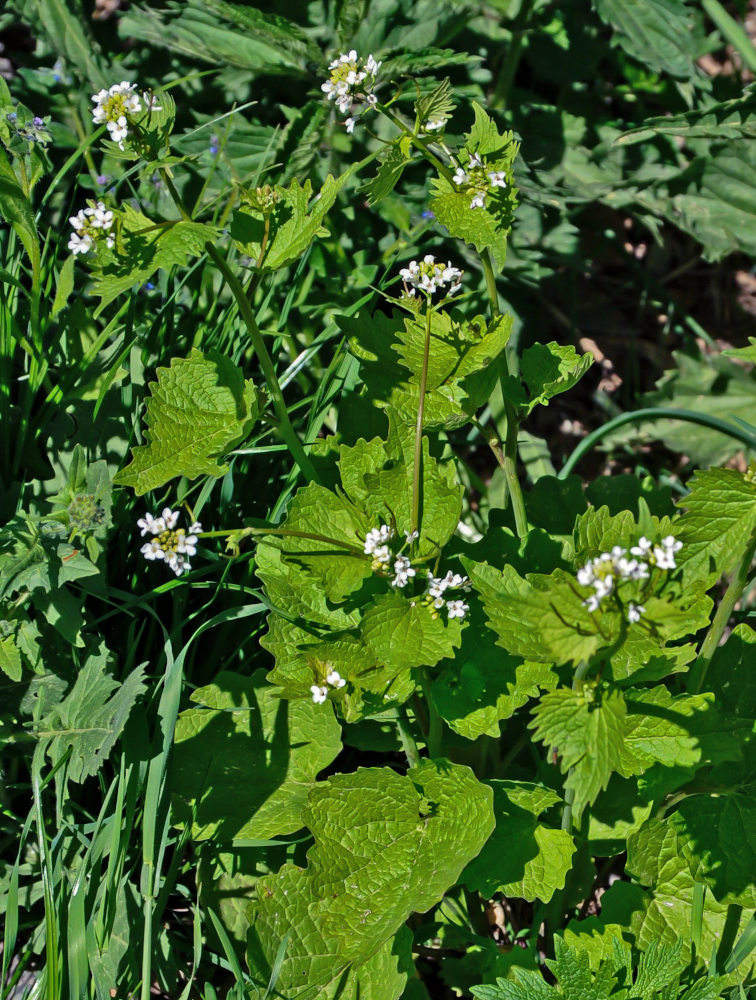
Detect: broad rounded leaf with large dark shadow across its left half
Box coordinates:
(173, 671, 341, 842)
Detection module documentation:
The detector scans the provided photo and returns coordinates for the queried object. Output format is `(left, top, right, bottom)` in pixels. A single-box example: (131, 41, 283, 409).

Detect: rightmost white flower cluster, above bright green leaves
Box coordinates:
(577, 535, 682, 623)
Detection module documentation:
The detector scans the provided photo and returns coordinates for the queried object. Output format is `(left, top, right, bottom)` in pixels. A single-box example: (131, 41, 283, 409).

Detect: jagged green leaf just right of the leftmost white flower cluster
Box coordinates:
(93, 210, 219, 316)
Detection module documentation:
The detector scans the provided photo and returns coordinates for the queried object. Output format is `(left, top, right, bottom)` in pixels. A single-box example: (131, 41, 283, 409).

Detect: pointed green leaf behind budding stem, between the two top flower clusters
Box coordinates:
(229, 172, 357, 272)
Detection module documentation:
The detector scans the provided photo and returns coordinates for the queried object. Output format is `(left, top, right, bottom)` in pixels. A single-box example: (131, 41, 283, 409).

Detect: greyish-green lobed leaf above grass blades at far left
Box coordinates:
(34, 644, 145, 782)
